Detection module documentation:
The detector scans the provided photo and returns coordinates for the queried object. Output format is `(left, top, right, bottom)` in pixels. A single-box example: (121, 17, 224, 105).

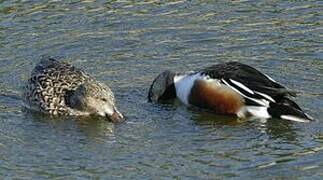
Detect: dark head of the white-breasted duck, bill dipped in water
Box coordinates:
(148, 71, 176, 102)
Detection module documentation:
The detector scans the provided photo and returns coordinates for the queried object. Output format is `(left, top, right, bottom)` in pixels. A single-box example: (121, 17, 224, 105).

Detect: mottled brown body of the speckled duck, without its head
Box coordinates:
(23, 58, 91, 114)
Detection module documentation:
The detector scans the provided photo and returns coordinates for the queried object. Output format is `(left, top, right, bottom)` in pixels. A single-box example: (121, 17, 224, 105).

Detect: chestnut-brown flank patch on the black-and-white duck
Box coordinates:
(189, 80, 245, 114)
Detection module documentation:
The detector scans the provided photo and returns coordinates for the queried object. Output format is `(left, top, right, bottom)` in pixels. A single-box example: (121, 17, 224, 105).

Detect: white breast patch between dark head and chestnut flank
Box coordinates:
(174, 73, 208, 105)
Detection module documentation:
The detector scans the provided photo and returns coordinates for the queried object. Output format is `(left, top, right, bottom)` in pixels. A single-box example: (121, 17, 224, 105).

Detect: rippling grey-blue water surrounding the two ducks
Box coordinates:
(0, 0, 323, 179)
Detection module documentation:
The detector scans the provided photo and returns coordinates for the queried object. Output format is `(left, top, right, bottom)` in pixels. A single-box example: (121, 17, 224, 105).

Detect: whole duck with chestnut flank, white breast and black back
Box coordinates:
(148, 62, 312, 122)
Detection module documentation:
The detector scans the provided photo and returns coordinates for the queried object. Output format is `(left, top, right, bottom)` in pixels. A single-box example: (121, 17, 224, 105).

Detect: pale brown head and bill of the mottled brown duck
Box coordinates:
(66, 82, 125, 123)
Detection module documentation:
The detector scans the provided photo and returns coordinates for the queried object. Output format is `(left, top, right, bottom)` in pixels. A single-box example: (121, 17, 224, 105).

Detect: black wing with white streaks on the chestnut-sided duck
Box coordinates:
(201, 62, 295, 101)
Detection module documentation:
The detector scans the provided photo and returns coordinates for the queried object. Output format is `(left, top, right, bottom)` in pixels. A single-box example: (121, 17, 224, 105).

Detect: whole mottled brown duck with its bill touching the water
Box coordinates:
(22, 57, 125, 123)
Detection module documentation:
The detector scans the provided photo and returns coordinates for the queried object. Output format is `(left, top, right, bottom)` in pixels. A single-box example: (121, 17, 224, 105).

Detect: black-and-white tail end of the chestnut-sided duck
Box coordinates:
(238, 98, 314, 122)
